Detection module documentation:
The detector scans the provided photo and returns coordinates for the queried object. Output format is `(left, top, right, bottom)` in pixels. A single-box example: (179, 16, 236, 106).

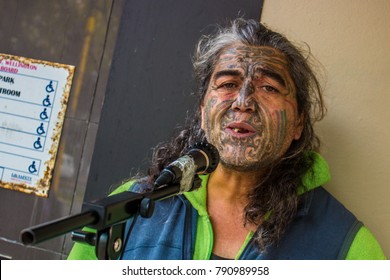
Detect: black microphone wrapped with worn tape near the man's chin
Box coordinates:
(154, 142, 219, 193)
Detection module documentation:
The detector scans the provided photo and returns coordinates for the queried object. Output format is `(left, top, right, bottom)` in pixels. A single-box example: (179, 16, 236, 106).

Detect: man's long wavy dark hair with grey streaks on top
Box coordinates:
(148, 18, 326, 249)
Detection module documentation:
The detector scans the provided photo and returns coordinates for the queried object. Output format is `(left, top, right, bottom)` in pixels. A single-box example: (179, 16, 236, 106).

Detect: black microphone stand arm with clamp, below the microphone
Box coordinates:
(20, 180, 200, 260)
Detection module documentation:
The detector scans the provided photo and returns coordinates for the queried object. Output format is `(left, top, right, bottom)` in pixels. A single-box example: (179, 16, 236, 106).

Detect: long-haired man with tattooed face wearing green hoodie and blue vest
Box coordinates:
(69, 19, 385, 259)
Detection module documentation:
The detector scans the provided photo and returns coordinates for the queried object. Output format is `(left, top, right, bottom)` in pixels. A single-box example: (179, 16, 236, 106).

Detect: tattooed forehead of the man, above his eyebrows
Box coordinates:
(214, 45, 294, 93)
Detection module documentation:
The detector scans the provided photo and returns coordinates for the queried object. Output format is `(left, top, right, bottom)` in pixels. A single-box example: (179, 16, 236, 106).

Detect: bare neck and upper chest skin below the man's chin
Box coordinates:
(207, 165, 259, 259)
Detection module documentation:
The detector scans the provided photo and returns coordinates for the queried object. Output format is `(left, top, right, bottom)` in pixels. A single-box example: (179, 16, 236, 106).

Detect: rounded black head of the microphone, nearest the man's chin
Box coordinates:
(188, 142, 219, 174)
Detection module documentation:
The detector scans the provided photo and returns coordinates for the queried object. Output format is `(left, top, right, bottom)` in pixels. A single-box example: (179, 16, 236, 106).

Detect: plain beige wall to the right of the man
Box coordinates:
(261, 0, 390, 258)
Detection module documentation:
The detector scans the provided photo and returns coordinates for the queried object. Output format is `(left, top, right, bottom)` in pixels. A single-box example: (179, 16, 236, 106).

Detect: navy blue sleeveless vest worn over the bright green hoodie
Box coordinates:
(122, 187, 362, 260)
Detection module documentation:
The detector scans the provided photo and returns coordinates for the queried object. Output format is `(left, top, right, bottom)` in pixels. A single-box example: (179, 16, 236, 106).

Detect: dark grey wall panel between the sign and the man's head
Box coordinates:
(84, 0, 263, 201)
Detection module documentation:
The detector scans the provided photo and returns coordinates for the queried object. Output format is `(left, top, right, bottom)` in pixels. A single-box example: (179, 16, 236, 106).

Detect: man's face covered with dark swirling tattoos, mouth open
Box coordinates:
(201, 44, 302, 171)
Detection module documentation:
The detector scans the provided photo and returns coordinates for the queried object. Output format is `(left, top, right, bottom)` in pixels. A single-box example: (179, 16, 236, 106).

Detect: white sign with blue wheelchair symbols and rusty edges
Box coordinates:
(0, 54, 74, 197)
